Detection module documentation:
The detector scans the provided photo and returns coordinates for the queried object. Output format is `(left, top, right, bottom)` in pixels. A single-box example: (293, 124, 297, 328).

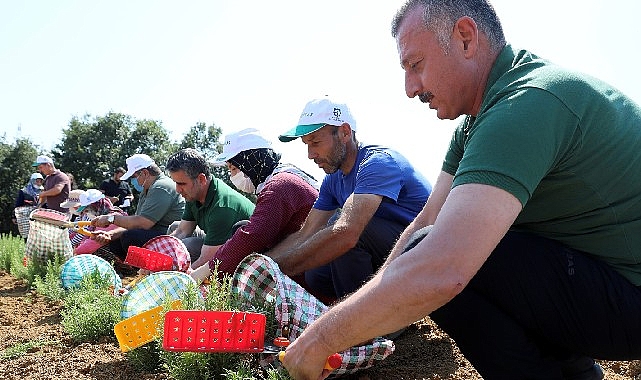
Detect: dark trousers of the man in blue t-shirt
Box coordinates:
(305, 217, 406, 298)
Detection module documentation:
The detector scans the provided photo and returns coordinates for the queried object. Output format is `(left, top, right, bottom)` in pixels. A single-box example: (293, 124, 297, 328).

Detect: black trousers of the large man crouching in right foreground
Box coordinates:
(406, 227, 641, 380)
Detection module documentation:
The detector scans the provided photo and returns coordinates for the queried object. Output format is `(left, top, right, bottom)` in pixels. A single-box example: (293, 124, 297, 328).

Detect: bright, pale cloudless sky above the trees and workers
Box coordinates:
(0, 0, 641, 183)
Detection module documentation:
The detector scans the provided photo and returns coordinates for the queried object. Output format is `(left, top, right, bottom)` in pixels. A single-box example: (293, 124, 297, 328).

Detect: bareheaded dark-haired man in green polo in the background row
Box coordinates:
(166, 148, 254, 268)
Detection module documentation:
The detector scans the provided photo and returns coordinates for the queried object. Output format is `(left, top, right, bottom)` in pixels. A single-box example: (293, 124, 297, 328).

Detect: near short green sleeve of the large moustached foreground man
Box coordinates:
(444, 88, 578, 206)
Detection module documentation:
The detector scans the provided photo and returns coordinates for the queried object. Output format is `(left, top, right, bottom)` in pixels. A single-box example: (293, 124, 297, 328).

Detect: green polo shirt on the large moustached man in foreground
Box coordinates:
(443, 45, 641, 285)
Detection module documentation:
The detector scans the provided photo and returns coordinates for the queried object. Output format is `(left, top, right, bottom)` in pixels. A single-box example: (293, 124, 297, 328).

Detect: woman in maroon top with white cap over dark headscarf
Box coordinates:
(192, 128, 318, 281)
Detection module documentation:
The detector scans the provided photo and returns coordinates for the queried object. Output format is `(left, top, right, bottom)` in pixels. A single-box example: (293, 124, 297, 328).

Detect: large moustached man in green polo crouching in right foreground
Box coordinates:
(282, 0, 641, 380)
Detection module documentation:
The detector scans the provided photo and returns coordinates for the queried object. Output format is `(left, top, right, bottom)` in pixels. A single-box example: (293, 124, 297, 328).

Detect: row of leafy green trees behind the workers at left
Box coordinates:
(0, 112, 238, 233)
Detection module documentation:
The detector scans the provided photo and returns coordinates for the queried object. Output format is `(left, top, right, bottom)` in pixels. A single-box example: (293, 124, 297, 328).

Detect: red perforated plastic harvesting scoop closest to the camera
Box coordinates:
(162, 310, 266, 353)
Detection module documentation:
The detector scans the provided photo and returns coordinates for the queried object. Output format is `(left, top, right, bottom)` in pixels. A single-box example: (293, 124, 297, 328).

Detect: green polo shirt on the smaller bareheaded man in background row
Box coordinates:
(182, 177, 254, 245)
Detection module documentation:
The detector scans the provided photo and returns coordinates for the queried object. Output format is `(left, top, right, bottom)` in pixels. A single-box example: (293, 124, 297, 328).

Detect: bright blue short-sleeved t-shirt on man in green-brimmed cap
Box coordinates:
(314, 144, 432, 225)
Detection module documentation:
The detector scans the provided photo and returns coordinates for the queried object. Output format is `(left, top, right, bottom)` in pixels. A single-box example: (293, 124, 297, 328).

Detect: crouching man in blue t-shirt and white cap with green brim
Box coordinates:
(268, 98, 432, 299)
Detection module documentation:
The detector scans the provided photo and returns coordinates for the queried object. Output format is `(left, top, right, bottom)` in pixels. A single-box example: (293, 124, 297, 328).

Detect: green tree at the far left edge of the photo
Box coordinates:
(0, 136, 38, 234)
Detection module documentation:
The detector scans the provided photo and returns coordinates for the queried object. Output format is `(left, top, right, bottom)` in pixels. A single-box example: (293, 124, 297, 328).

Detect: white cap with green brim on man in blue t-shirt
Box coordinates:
(278, 97, 356, 142)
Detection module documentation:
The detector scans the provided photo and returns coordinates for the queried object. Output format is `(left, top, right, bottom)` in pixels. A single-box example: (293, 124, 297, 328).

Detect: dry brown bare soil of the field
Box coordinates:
(0, 272, 641, 380)
